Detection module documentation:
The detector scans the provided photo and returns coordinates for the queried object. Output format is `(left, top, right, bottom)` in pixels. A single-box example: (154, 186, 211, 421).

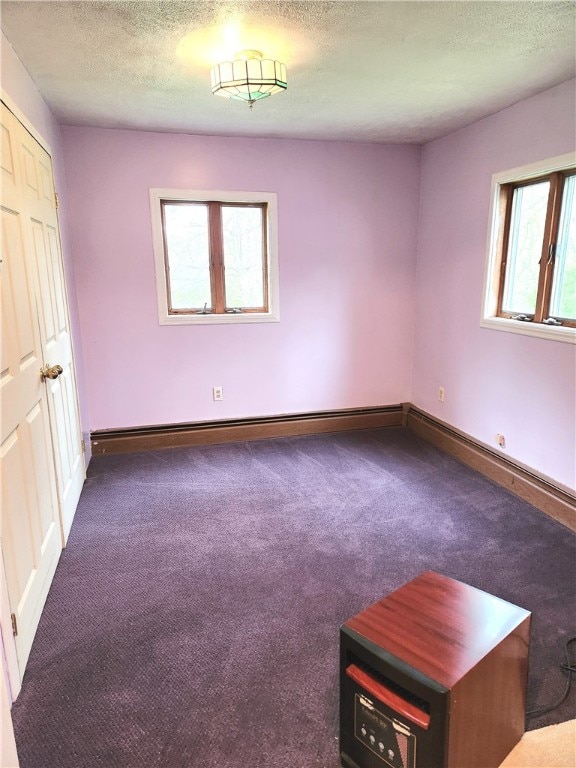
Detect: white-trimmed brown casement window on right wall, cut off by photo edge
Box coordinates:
(481, 153, 576, 343)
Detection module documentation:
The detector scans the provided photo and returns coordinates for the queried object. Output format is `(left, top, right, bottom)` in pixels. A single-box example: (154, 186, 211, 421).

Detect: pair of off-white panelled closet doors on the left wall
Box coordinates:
(0, 104, 85, 675)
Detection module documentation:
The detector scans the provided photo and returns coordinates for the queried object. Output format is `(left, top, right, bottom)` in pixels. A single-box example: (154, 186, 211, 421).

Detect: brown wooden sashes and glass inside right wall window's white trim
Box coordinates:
(496, 168, 576, 326)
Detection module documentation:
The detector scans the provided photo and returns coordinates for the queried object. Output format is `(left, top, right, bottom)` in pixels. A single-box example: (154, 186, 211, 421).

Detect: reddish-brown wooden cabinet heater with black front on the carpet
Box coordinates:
(340, 571, 531, 768)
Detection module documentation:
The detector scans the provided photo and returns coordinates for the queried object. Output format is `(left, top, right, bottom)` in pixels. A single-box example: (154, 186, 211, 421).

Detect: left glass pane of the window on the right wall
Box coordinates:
(502, 181, 550, 315)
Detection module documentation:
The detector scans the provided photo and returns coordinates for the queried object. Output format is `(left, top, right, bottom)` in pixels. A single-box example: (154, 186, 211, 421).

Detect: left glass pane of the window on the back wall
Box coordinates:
(164, 203, 212, 310)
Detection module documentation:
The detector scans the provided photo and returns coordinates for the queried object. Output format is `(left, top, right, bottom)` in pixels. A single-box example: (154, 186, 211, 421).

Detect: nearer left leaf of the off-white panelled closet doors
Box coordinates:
(0, 113, 62, 674)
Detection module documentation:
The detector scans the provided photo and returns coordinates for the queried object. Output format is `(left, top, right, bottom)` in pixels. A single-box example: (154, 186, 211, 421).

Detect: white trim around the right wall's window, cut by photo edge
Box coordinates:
(480, 152, 576, 344)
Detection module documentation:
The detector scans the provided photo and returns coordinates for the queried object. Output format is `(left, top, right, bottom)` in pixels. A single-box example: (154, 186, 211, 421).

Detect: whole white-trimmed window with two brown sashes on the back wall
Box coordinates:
(150, 189, 280, 325)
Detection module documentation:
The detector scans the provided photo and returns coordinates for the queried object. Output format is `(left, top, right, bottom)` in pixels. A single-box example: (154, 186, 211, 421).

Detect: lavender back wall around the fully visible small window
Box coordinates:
(63, 124, 420, 429)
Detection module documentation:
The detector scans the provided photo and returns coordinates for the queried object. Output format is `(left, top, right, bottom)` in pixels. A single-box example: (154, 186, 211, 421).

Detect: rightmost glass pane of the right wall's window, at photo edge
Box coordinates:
(550, 176, 576, 320)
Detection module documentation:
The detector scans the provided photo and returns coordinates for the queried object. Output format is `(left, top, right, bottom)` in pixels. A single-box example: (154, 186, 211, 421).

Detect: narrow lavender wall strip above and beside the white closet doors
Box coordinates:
(0, 34, 90, 459)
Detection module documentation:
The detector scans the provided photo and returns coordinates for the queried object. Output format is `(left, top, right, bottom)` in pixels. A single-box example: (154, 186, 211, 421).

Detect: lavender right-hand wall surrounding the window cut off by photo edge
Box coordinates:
(412, 81, 576, 488)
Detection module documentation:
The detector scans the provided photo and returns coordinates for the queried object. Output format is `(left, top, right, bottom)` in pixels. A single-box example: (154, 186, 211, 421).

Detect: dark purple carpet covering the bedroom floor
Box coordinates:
(13, 428, 576, 768)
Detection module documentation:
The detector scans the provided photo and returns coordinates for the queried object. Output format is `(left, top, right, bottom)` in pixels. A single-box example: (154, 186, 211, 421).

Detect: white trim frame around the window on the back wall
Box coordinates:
(150, 188, 280, 325)
